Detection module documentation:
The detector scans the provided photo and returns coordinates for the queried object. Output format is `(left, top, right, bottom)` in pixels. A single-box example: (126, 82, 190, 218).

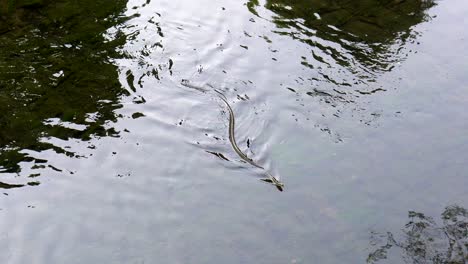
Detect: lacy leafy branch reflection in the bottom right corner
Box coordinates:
(367, 205, 468, 264)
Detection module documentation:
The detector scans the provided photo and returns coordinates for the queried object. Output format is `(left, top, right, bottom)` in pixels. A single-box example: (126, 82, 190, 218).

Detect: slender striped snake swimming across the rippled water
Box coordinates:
(182, 81, 284, 191)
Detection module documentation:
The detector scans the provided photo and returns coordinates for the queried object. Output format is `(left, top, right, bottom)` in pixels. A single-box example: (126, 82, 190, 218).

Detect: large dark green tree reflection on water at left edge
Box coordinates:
(0, 0, 128, 184)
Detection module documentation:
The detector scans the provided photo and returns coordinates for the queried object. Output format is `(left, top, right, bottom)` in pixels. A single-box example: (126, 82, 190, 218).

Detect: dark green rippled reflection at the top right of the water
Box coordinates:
(247, 0, 435, 86)
